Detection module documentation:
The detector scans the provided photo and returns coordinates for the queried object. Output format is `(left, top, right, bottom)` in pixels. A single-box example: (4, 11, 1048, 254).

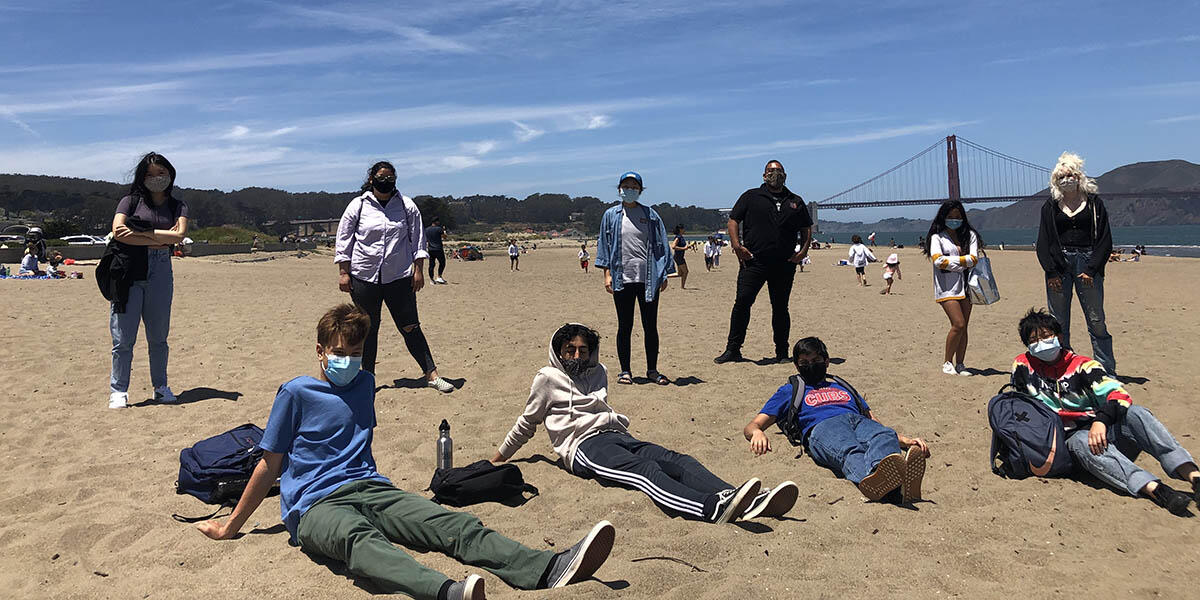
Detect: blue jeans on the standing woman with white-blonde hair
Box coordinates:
(1046, 248, 1117, 376)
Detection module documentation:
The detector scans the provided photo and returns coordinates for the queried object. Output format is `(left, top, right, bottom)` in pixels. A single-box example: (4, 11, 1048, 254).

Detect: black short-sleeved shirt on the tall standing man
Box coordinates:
(730, 184, 812, 260)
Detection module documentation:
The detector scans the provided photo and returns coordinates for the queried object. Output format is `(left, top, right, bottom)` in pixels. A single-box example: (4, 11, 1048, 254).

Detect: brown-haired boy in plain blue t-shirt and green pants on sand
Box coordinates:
(197, 304, 614, 600)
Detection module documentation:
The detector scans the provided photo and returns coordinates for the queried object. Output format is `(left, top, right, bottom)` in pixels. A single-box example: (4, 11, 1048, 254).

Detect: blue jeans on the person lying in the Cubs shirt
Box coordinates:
(808, 413, 900, 485)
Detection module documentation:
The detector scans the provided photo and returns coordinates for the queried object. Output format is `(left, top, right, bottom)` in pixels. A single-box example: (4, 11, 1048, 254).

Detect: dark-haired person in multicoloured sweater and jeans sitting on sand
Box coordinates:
(1013, 310, 1200, 515)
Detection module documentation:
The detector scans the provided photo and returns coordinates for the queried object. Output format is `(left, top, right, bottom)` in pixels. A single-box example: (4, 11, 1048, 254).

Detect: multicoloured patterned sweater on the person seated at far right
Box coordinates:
(1013, 349, 1132, 426)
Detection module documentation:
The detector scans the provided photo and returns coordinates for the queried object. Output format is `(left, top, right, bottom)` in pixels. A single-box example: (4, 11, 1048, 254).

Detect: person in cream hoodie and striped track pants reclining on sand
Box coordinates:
(492, 323, 799, 523)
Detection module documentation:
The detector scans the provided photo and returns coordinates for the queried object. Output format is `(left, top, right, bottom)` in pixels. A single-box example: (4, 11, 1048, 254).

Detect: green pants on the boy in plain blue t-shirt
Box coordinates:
(296, 481, 554, 600)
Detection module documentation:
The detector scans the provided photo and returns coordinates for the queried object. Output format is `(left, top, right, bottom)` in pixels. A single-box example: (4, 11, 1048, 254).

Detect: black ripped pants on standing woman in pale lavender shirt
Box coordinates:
(350, 276, 437, 374)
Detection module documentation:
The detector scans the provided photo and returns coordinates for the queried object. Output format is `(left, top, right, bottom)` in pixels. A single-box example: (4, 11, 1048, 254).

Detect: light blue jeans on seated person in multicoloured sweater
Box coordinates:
(1067, 404, 1195, 496)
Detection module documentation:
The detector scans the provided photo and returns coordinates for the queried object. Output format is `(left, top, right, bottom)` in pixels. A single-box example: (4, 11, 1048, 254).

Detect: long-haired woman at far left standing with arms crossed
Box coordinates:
(108, 152, 187, 408)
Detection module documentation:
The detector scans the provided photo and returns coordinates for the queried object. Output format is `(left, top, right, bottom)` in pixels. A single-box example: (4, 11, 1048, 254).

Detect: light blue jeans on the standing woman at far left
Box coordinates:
(108, 248, 175, 392)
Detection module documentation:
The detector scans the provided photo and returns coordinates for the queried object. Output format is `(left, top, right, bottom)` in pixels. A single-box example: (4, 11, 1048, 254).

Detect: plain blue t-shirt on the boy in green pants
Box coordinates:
(259, 371, 390, 540)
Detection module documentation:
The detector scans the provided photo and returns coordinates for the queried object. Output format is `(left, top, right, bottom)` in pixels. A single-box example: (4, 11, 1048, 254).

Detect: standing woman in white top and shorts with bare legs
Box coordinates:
(922, 200, 983, 376)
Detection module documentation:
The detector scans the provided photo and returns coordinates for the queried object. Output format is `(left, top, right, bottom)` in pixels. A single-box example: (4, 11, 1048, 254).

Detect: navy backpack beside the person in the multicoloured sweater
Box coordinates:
(988, 384, 1075, 479)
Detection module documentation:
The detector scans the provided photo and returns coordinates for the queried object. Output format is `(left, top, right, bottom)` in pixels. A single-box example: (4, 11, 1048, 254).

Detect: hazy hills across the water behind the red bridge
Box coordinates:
(821, 160, 1200, 233)
